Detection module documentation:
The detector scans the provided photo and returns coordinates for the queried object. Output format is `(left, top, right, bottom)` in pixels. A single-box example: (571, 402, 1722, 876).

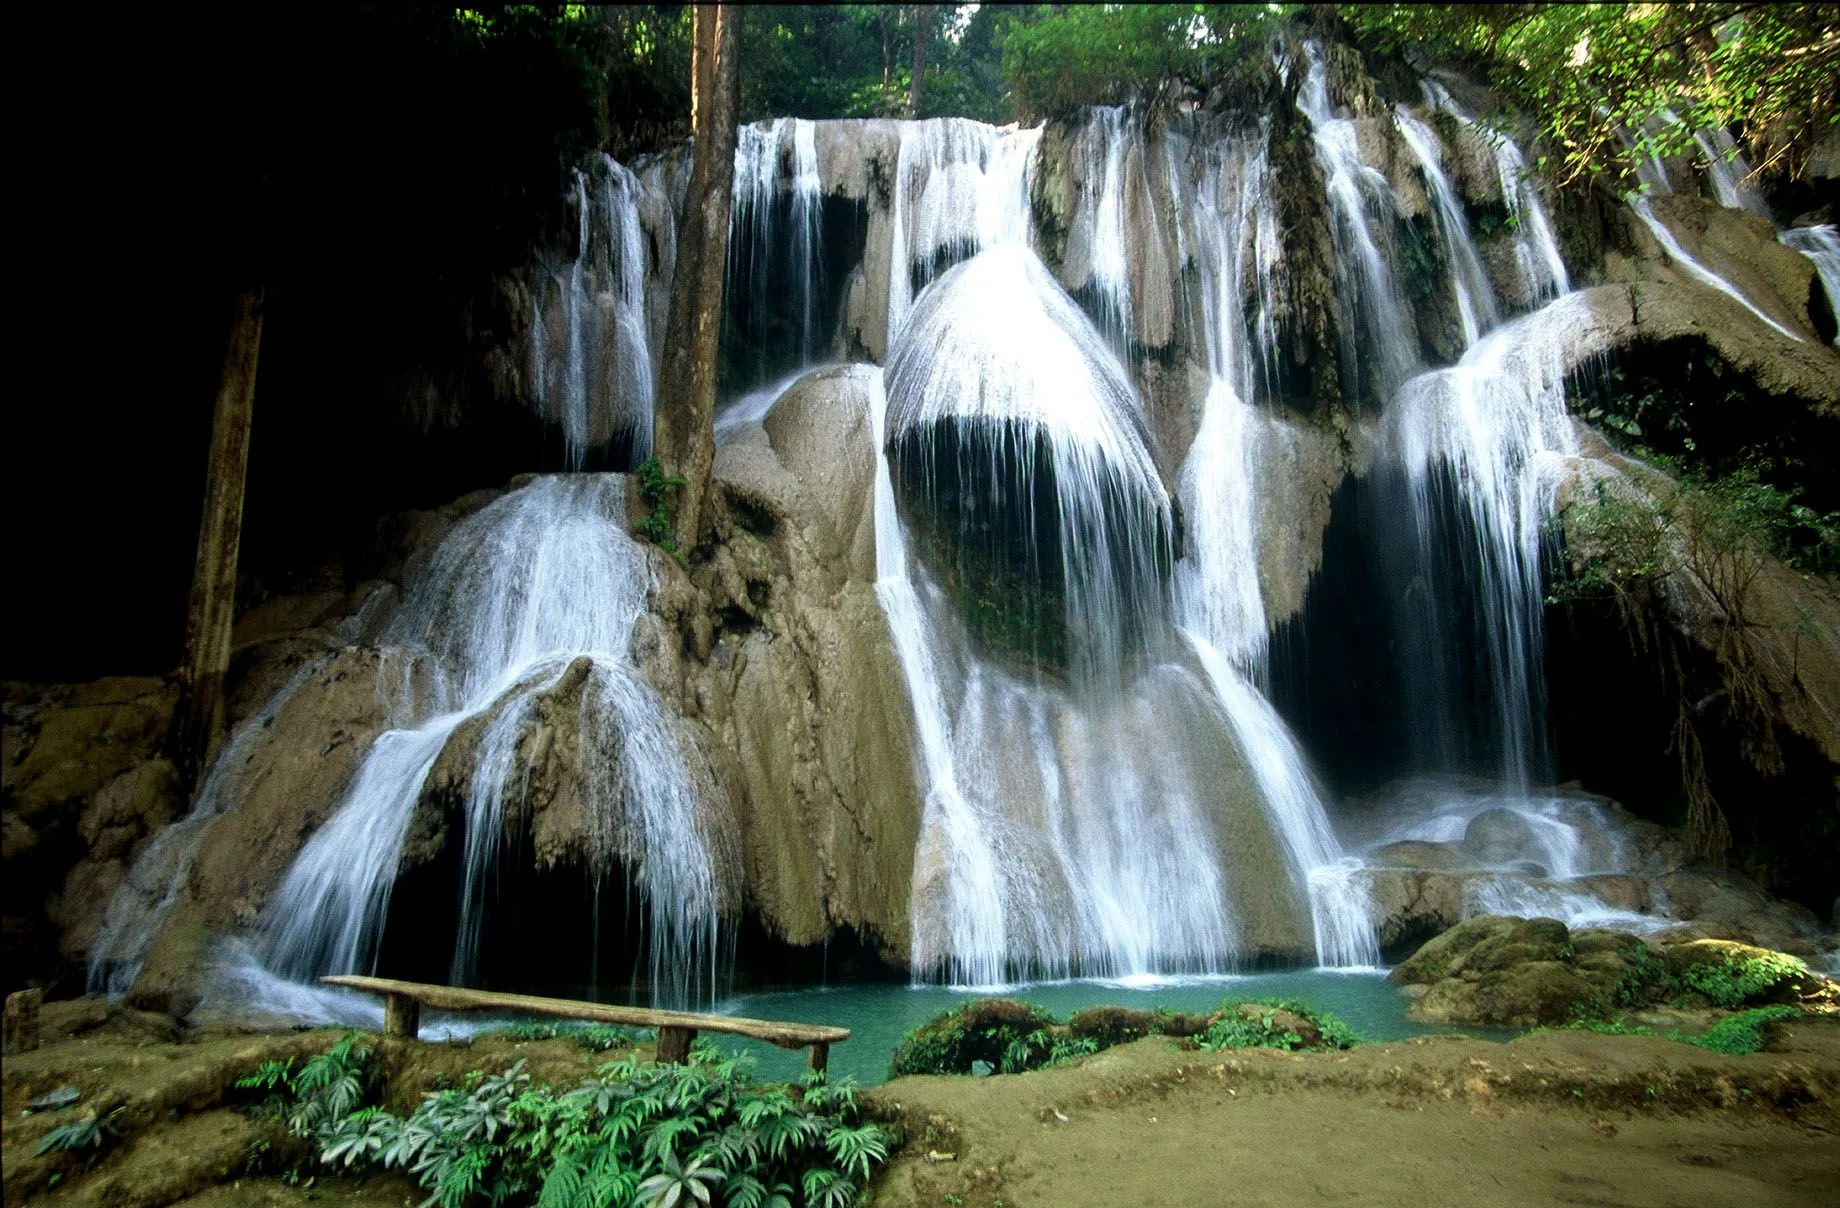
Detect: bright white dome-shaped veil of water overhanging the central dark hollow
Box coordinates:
(887, 243, 1174, 682)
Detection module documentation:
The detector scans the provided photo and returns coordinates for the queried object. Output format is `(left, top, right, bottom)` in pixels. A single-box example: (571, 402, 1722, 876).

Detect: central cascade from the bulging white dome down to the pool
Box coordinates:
(878, 245, 1273, 984)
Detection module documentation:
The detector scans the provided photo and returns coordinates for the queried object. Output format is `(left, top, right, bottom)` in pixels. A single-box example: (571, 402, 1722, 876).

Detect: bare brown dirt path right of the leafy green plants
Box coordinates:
(874, 1024, 1840, 1208)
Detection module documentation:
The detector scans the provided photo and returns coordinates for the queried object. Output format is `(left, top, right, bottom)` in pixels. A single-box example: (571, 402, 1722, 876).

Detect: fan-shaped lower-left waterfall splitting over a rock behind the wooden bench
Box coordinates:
(259, 474, 734, 1000)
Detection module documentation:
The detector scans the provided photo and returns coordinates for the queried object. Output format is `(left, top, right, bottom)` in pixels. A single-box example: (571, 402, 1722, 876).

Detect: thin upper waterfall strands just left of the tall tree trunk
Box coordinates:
(530, 154, 655, 469)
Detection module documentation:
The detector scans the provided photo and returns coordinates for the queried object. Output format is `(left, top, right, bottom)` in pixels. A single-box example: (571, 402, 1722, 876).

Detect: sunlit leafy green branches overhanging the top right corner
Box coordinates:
(1336, 4, 1840, 180)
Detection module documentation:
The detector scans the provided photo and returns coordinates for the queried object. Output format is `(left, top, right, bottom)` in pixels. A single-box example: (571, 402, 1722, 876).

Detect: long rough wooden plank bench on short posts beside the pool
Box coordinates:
(320, 974, 850, 1070)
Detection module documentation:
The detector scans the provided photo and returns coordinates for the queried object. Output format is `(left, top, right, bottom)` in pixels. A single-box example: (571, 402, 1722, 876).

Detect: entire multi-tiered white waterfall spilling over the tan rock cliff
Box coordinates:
(96, 37, 1836, 1000)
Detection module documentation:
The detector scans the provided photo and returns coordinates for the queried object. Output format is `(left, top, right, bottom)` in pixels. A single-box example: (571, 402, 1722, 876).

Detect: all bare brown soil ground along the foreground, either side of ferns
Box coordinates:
(0, 1004, 1840, 1208)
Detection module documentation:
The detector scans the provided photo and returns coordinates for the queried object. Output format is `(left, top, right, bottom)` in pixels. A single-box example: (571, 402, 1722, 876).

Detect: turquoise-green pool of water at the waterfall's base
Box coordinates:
(691, 969, 1507, 1087)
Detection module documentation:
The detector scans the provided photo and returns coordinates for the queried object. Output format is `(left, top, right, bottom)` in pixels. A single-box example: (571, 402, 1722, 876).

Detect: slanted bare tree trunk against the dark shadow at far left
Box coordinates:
(173, 285, 263, 780)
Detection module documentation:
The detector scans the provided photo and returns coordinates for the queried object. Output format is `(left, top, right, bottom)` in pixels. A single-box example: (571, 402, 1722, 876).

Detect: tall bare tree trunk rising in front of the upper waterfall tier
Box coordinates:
(653, 4, 742, 553)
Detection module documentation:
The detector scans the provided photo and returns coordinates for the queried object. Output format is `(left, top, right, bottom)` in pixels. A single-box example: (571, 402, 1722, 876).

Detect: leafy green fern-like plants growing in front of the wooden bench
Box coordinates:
(263, 1037, 892, 1208)
